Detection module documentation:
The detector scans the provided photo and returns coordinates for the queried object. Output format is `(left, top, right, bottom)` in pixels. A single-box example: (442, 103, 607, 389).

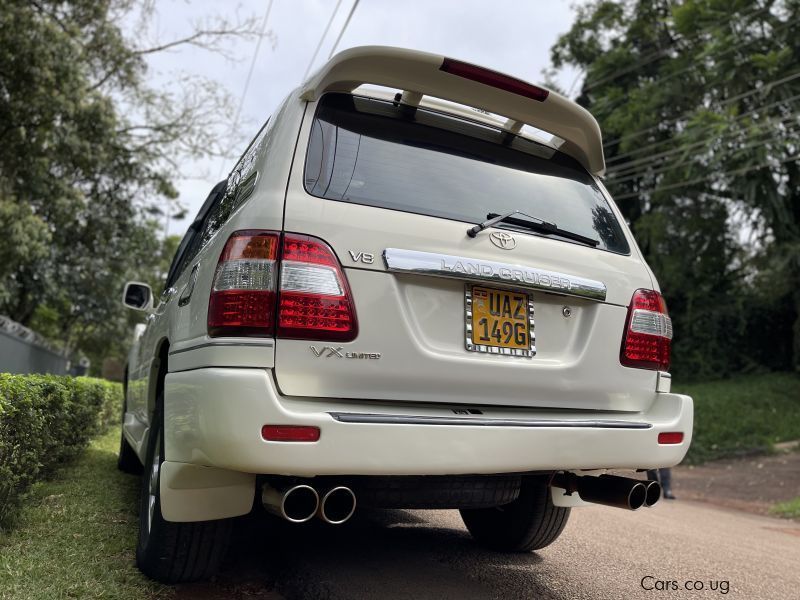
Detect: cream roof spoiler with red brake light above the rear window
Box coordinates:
(301, 46, 605, 175)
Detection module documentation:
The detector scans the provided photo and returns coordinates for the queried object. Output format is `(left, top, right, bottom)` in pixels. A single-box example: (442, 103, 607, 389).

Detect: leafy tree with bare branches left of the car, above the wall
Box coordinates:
(0, 0, 271, 376)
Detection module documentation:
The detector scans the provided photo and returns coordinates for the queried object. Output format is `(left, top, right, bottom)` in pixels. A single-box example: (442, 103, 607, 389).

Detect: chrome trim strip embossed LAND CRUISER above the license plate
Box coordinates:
(383, 248, 607, 302)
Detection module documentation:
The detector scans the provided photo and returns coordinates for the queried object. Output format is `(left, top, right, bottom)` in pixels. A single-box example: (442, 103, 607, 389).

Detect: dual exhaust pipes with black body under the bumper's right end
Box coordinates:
(550, 473, 661, 510)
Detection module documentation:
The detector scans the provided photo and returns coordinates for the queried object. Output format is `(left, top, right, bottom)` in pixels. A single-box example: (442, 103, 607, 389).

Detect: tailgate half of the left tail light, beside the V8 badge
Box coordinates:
(278, 234, 358, 342)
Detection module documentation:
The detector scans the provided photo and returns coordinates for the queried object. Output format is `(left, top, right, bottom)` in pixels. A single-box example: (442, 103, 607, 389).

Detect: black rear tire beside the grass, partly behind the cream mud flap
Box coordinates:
(136, 399, 232, 583)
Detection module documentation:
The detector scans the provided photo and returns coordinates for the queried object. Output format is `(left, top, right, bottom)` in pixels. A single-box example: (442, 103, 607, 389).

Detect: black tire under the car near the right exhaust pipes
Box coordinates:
(461, 477, 570, 552)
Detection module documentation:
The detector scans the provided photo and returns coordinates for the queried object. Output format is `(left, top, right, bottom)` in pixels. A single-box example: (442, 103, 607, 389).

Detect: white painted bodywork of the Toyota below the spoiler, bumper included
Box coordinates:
(123, 53, 693, 521)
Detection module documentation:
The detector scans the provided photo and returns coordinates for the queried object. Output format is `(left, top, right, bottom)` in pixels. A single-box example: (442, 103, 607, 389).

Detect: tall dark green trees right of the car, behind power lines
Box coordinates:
(552, 0, 800, 376)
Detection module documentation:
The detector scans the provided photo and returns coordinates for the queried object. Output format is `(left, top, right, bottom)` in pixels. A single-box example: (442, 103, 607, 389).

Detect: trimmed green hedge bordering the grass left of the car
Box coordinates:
(0, 373, 122, 527)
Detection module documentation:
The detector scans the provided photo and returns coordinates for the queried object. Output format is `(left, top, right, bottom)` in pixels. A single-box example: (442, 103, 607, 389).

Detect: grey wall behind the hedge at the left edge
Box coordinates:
(0, 316, 67, 375)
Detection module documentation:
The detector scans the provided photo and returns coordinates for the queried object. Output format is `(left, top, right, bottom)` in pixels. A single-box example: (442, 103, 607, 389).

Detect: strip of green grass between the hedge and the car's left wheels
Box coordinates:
(0, 428, 172, 600)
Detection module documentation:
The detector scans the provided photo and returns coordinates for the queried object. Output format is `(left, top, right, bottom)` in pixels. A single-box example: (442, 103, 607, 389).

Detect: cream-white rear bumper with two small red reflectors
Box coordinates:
(164, 368, 693, 477)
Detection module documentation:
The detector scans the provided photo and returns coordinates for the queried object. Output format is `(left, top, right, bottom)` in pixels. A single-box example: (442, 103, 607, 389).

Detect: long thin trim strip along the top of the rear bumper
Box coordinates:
(328, 412, 652, 429)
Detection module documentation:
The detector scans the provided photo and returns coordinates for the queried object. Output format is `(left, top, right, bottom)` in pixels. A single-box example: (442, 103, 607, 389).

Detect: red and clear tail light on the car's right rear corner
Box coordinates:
(619, 290, 672, 371)
